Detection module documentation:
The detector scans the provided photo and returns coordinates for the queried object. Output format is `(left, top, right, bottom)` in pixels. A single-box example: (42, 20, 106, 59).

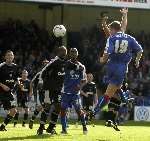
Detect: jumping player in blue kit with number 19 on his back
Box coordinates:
(94, 21, 143, 117)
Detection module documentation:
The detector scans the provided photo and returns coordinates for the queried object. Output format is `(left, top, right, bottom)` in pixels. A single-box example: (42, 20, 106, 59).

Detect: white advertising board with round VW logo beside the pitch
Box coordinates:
(134, 106, 150, 121)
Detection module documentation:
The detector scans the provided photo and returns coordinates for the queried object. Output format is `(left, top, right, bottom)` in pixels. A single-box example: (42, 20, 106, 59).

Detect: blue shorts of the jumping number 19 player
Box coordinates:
(106, 63, 128, 86)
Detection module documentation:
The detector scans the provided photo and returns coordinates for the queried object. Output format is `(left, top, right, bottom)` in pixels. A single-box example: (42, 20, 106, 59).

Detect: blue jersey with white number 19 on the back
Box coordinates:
(105, 32, 142, 64)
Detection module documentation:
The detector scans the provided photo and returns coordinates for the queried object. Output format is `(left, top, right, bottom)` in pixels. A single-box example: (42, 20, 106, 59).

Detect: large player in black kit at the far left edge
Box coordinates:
(0, 50, 19, 131)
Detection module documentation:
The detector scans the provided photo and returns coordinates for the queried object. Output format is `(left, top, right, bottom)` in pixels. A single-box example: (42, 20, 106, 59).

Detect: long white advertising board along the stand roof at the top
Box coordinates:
(20, 0, 150, 9)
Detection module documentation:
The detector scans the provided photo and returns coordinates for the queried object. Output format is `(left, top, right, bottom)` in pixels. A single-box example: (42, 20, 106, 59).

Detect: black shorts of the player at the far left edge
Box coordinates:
(0, 92, 15, 110)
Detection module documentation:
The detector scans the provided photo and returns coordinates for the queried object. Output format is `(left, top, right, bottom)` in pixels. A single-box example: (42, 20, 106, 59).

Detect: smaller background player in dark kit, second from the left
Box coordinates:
(14, 70, 31, 127)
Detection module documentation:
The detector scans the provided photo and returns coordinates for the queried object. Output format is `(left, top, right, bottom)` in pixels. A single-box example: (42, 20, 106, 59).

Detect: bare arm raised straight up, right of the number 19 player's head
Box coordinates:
(120, 8, 128, 32)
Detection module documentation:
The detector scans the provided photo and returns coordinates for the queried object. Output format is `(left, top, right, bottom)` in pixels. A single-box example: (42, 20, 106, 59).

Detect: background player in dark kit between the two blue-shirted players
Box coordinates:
(81, 73, 97, 124)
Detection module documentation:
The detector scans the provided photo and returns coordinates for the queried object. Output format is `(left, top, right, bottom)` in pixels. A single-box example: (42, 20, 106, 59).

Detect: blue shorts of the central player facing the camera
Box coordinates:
(61, 93, 82, 110)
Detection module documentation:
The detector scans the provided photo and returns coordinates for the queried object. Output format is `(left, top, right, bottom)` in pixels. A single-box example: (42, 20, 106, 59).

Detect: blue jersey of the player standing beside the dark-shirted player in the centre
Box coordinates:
(62, 62, 86, 94)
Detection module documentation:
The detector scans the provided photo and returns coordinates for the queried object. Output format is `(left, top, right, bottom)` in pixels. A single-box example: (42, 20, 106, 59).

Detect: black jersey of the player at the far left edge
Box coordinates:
(0, 62, 19, 92)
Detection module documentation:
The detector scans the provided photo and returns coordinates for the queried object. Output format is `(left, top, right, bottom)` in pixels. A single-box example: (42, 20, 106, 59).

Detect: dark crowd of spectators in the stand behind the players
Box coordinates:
(0, 19, 150, 105)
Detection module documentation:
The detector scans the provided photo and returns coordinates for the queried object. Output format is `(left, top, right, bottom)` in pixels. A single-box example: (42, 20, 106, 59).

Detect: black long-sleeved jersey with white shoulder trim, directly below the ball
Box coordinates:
(41, 56, 78, 90)
